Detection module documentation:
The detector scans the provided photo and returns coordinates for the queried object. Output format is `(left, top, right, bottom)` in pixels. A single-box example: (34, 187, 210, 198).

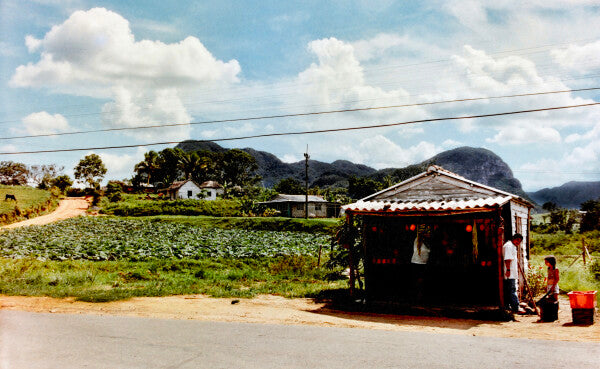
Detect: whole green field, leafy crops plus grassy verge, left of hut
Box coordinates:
(0, 217, 347, 301)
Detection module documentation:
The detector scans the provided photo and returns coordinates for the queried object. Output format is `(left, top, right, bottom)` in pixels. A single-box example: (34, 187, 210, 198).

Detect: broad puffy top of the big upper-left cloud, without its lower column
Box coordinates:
(11, 8, 240, 91)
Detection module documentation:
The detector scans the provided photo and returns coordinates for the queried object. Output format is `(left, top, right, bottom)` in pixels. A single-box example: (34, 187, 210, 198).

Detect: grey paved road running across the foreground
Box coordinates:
(0, 311, 600, 369)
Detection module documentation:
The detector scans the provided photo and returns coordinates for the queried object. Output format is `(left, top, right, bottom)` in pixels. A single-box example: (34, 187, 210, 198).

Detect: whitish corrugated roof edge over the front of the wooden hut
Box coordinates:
(342, 196, 513, 212)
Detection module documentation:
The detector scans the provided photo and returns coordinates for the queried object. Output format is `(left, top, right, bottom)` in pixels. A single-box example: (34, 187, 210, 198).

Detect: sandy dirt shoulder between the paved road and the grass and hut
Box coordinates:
(0, 295, 600, 342)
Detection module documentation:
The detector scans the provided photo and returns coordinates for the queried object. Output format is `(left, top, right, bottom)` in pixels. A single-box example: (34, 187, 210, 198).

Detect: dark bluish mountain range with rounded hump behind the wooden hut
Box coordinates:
(177, 141, 600, 208)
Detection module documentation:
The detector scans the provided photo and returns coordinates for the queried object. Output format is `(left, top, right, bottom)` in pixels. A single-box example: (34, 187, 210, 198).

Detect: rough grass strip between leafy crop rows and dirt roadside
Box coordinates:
(0, 256, 347, 302)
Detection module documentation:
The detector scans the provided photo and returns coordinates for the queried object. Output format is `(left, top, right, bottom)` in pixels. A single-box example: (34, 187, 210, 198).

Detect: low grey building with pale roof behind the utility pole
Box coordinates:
(260, 194, 340, 218)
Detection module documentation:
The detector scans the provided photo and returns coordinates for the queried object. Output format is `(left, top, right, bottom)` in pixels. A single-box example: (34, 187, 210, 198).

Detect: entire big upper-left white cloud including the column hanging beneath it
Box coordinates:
(10, 8, 241, 140)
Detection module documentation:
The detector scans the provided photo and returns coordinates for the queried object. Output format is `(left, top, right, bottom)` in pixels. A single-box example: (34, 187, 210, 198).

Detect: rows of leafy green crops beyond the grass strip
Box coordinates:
(0, 217, 328, 261)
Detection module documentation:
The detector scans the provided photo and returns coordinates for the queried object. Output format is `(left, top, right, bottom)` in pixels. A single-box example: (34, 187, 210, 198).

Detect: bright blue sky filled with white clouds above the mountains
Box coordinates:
(0, 0, 600, 191)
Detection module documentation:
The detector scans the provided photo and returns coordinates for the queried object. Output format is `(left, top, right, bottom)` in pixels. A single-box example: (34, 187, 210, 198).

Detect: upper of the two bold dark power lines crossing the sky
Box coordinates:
(0, 87, 600, 140)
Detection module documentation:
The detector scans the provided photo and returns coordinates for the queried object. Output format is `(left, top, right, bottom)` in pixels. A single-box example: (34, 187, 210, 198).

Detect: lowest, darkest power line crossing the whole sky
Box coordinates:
(0, 102, 600, 155)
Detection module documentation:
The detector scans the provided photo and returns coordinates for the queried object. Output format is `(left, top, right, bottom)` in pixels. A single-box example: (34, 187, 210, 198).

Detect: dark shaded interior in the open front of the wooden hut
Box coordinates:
(364, 213, 499, 306)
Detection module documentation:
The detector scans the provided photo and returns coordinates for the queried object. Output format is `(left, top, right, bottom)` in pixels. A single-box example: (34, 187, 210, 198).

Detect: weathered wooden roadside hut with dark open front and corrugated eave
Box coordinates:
(343, 165, 533, 307)
